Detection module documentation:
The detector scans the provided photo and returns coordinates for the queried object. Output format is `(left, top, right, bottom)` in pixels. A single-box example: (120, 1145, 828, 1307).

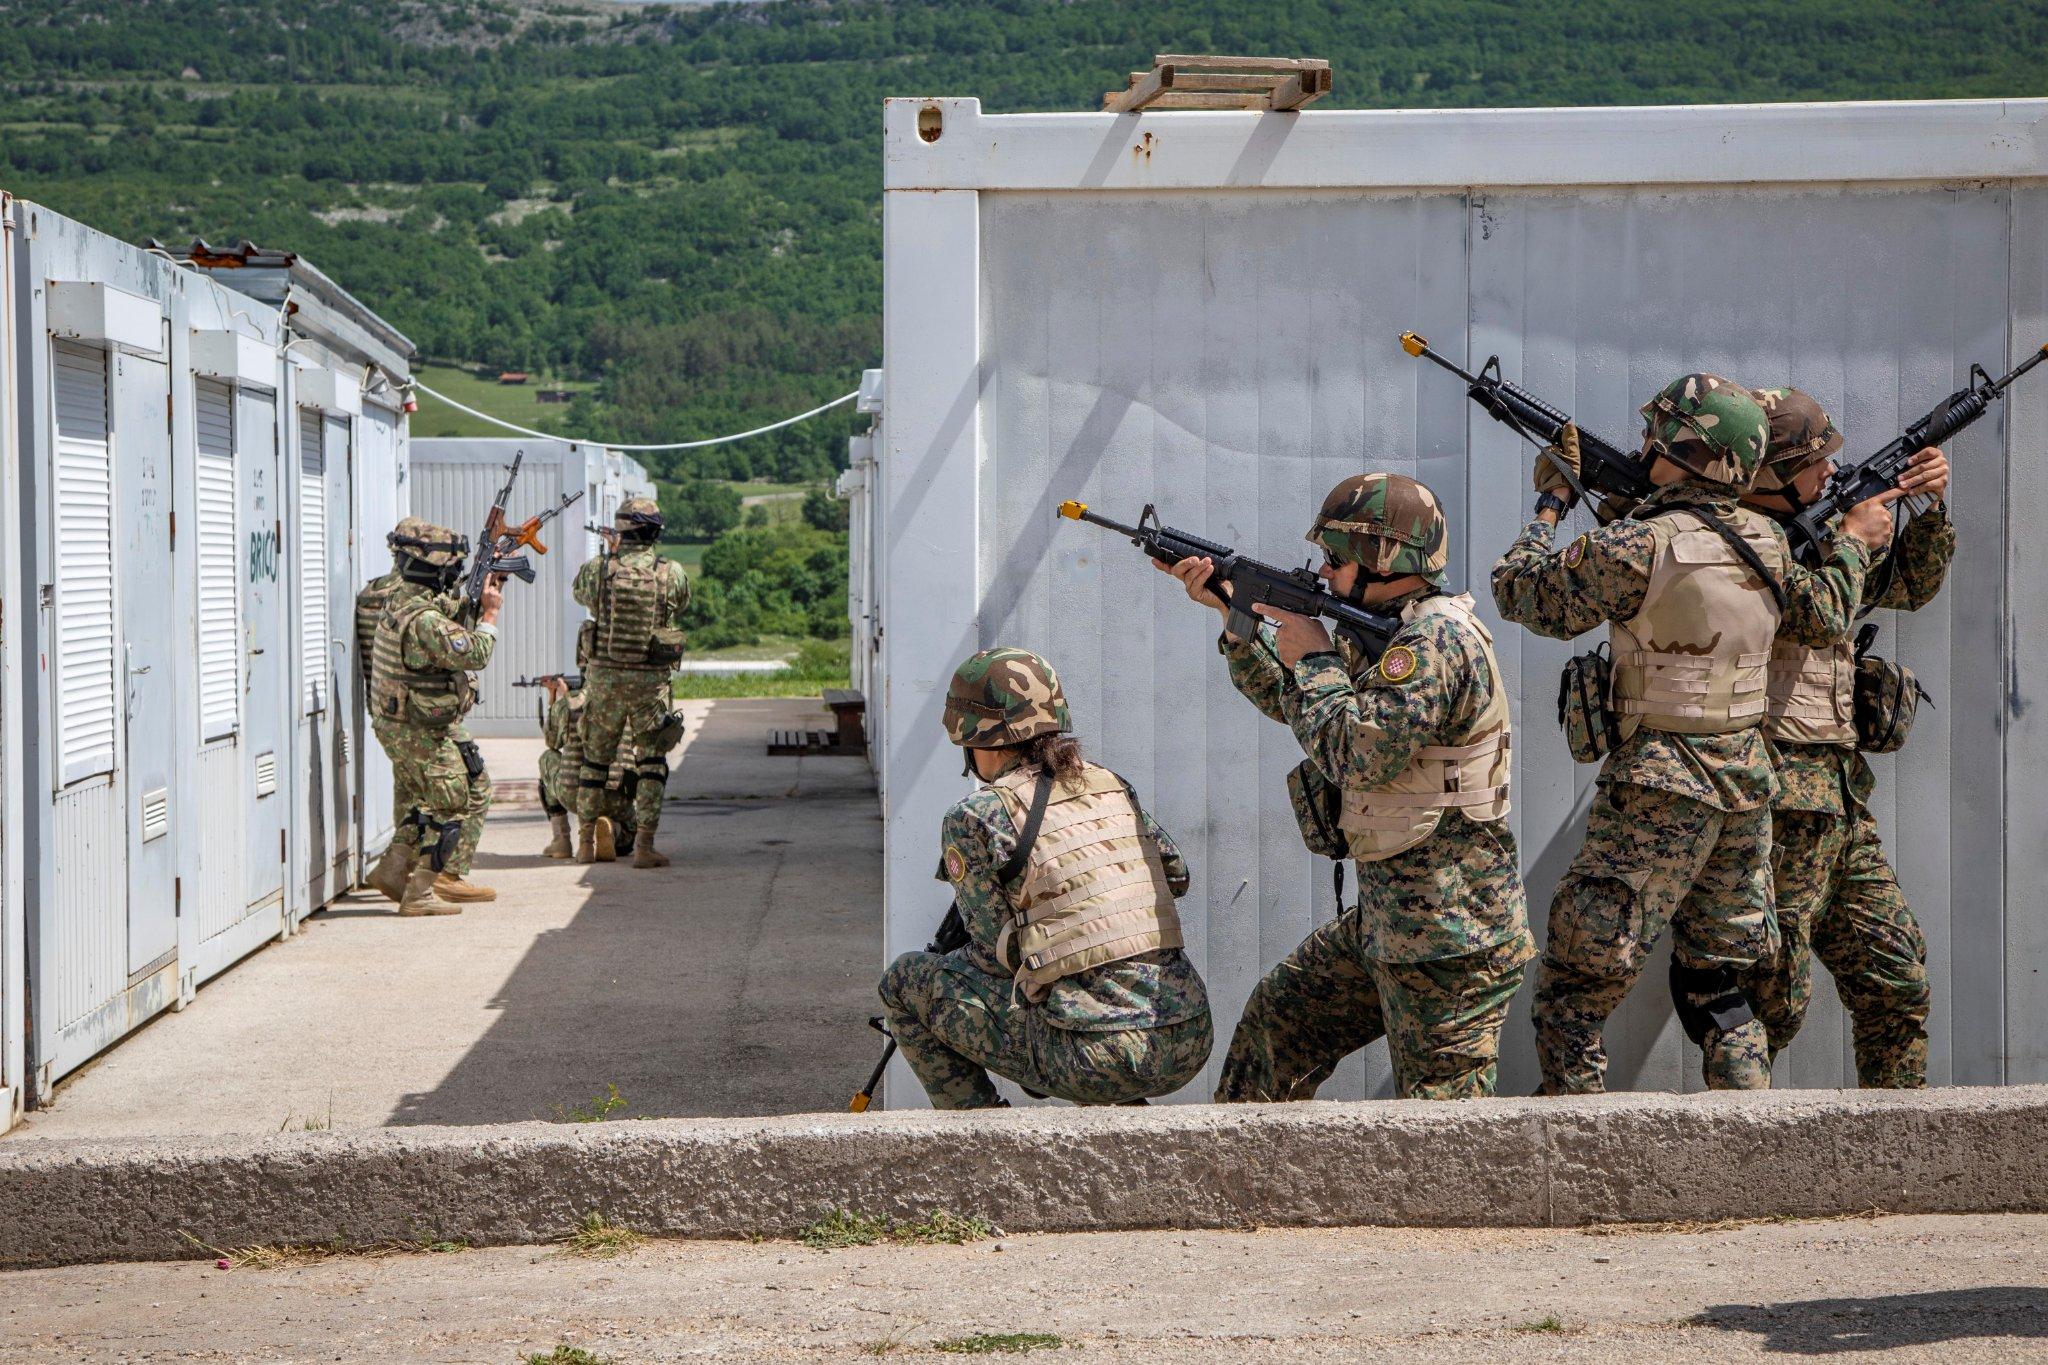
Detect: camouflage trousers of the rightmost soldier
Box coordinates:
(1743, 806, 1933, 1089)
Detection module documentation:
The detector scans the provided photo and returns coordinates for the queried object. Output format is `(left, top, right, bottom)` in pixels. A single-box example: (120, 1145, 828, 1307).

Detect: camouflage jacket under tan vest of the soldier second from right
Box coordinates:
(1493, 479, 1870, 810)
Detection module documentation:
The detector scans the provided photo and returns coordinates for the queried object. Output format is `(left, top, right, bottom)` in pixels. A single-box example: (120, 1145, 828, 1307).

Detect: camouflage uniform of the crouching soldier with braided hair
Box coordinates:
(879, 649, 1212, 1109)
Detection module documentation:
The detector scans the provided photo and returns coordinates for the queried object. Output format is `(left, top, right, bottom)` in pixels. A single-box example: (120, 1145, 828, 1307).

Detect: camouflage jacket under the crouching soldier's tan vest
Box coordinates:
(938, 753, 1208, 1031)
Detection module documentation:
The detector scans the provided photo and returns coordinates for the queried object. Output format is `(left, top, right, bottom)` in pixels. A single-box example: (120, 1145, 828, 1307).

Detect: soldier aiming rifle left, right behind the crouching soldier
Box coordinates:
(1161, 475, 1536, 1101)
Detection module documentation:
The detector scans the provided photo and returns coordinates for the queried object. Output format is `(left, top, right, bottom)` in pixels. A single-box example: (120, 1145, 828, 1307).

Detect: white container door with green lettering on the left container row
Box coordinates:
(236, 393, 297, 911)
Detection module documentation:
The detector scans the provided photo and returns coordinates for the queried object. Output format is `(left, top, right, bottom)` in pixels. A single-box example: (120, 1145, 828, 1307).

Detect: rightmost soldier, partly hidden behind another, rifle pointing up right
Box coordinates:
(1743, 389, 1956, 1089)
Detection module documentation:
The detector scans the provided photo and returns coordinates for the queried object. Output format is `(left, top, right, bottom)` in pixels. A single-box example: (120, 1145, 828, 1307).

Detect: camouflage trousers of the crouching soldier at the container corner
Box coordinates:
(881, 952, 1214, 1109)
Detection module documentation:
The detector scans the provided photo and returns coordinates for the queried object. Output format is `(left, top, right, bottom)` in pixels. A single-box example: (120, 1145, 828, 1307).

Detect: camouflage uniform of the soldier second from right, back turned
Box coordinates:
(1493, 381, 1868, 1093)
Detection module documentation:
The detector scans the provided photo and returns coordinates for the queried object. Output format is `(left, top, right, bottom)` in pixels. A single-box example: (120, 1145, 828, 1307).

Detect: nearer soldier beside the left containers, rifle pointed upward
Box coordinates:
(371, 522, 502, 915)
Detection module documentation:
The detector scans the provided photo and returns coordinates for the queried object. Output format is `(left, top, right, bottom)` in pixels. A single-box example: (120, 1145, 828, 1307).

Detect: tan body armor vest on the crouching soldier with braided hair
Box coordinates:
(989, 763, 1182, 1001)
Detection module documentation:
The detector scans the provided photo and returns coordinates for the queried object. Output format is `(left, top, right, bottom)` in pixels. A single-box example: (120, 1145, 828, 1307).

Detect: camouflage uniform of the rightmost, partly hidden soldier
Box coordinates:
(1745, 391, 1956, 1089)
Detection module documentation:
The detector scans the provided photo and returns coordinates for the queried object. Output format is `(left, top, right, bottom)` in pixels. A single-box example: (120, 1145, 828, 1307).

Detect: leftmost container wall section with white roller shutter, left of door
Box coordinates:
(35, 342, 129, 1078)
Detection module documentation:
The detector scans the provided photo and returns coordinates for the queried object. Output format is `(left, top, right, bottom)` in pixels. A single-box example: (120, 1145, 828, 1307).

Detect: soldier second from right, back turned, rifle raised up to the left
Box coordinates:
(1493, 375, 1890, 1095)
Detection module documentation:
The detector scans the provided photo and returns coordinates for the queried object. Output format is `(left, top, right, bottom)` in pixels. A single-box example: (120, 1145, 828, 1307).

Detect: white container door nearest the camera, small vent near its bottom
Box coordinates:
(115, 354, 182, 972)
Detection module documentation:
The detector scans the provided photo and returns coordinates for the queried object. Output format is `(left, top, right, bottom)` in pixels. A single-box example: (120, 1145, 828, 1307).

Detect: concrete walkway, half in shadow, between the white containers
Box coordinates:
(6, 700, 881, 1142)
